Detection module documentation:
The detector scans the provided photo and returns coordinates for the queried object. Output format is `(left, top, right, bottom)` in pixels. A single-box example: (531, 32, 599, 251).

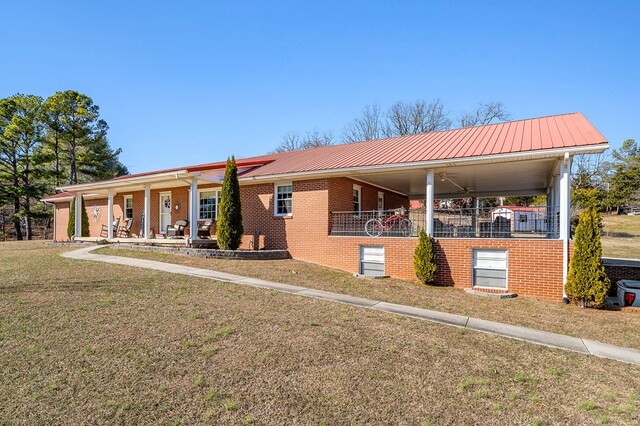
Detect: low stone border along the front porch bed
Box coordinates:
(104, 244, 291, 260)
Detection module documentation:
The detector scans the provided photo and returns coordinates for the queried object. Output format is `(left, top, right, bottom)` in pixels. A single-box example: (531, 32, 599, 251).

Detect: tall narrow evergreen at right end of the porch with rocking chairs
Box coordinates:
(216, 156, 244, 250)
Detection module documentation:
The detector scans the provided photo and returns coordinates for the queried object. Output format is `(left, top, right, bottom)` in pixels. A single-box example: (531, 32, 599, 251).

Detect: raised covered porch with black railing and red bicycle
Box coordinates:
(329, 153, 571, 240)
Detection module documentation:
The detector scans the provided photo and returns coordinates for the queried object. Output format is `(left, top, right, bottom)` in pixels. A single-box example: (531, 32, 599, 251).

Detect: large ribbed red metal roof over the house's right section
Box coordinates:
(243, 112, 607, 177)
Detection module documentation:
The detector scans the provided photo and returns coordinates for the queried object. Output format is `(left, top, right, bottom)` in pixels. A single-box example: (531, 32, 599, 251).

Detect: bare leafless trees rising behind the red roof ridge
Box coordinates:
(275, 99, 511, 152)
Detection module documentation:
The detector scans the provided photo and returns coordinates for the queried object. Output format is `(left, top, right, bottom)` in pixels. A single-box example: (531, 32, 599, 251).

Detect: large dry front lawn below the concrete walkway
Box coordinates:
(0, 243, 640, 425)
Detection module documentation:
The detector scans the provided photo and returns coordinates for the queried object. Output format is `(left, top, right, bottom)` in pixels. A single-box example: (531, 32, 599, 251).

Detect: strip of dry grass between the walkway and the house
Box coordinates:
(97, 247, 640, 349)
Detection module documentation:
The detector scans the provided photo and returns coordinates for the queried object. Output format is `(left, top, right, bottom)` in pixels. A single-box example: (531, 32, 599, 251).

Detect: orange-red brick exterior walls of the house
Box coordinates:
(51, 178, 562, 300)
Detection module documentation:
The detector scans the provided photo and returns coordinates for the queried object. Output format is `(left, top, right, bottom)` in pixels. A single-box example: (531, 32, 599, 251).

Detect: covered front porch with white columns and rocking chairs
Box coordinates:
(61, 170, 224, 247)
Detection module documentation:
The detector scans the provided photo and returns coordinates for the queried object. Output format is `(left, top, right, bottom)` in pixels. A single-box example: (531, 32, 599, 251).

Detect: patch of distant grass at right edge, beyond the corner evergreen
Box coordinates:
(602, 214, 640, 259)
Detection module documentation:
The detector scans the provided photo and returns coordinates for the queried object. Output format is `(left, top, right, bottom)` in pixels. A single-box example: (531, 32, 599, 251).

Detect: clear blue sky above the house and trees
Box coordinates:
(0, 0, 640, 172)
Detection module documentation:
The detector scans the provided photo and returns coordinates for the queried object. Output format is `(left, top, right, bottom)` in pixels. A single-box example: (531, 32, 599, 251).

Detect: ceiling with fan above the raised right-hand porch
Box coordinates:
(353, 158, 559, 199)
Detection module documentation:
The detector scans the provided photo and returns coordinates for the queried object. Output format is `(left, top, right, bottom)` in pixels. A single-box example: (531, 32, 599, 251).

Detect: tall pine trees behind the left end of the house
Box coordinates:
(0, 90, 128, 240)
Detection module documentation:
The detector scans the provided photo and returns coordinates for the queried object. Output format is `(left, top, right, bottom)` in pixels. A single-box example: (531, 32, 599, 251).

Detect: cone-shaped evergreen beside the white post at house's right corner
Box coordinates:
(565, 207, 611, 308)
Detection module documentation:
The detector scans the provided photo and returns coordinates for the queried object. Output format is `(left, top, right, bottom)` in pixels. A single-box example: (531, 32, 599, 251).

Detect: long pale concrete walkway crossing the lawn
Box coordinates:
(62, 246, 640, 365)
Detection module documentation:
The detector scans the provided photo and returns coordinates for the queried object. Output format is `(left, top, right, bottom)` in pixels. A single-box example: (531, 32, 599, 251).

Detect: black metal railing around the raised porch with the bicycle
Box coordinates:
(330, 206, 560, 238)
